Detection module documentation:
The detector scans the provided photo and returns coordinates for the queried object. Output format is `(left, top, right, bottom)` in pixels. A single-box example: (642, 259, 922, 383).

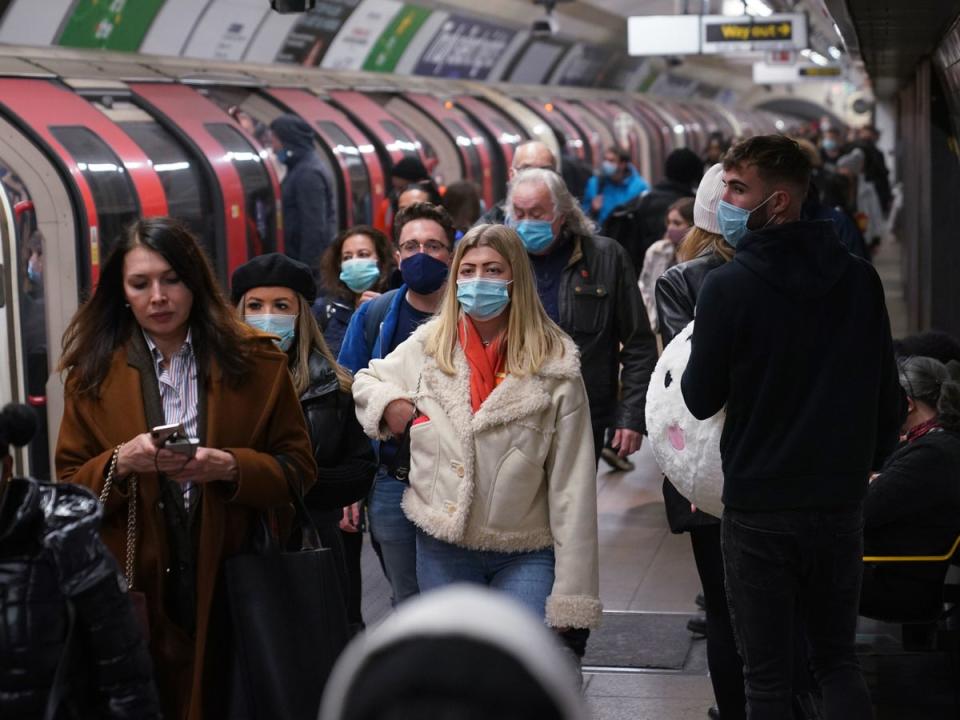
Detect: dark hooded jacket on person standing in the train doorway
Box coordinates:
(272, 116, 337, 268)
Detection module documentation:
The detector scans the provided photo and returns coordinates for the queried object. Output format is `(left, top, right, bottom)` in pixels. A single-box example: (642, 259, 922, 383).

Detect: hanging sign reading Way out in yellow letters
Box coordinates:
(700, 13, 807, 53)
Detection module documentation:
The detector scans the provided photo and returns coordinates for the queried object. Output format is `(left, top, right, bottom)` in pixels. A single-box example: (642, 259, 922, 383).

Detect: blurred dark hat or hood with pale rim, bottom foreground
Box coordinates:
(320, 585, 589, 720)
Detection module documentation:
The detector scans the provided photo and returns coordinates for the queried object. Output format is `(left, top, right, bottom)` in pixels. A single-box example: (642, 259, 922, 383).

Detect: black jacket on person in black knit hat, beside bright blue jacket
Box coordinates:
(603, 180, 693, 276)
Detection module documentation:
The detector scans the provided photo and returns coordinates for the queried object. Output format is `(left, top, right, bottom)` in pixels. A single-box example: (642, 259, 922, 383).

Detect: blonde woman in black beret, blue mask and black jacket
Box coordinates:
(230, 253, 376, 628)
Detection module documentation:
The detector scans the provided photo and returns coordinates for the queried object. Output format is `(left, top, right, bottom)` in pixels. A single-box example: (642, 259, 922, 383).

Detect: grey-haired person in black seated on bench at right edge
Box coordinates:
(860, 357, 960, 622)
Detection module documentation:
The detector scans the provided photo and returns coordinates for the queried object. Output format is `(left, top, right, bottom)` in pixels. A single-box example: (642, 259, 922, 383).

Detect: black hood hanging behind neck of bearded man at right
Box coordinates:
(734, 220, 851, 299)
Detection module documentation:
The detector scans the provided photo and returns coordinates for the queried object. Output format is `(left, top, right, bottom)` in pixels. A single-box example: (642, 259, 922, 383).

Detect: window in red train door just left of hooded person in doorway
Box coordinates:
(204, 123, 277, 257)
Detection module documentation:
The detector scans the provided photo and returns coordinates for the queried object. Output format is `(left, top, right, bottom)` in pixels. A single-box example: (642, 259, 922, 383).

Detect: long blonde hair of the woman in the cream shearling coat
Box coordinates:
(425, 225, 563, 376)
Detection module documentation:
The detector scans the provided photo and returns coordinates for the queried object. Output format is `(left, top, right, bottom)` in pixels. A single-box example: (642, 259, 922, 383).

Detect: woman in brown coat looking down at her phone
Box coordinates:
(56, 218, 316, 720)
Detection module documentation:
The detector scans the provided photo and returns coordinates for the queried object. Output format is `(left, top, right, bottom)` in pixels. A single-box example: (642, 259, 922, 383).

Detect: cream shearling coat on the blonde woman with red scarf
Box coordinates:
(353, 320, 602, 628)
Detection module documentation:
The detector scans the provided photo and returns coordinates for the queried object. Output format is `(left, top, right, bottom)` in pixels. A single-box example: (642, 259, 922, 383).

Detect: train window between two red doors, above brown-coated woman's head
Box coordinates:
(118, 122, 217, 267)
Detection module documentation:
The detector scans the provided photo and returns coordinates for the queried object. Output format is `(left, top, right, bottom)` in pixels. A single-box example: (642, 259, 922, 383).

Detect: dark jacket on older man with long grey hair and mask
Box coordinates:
(558, 235, 657, 432)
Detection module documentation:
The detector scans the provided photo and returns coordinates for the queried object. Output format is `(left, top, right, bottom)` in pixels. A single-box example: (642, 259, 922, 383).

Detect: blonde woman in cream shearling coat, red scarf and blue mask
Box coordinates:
(353, 225, 601, 630)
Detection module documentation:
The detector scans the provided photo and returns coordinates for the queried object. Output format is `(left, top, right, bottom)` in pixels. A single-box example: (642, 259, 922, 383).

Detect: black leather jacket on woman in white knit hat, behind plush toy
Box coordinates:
(654, 253, 726, 533)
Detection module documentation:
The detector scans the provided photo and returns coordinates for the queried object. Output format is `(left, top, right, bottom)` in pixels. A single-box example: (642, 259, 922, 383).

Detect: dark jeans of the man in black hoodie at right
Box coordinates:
(721, 508, 873, 720)
